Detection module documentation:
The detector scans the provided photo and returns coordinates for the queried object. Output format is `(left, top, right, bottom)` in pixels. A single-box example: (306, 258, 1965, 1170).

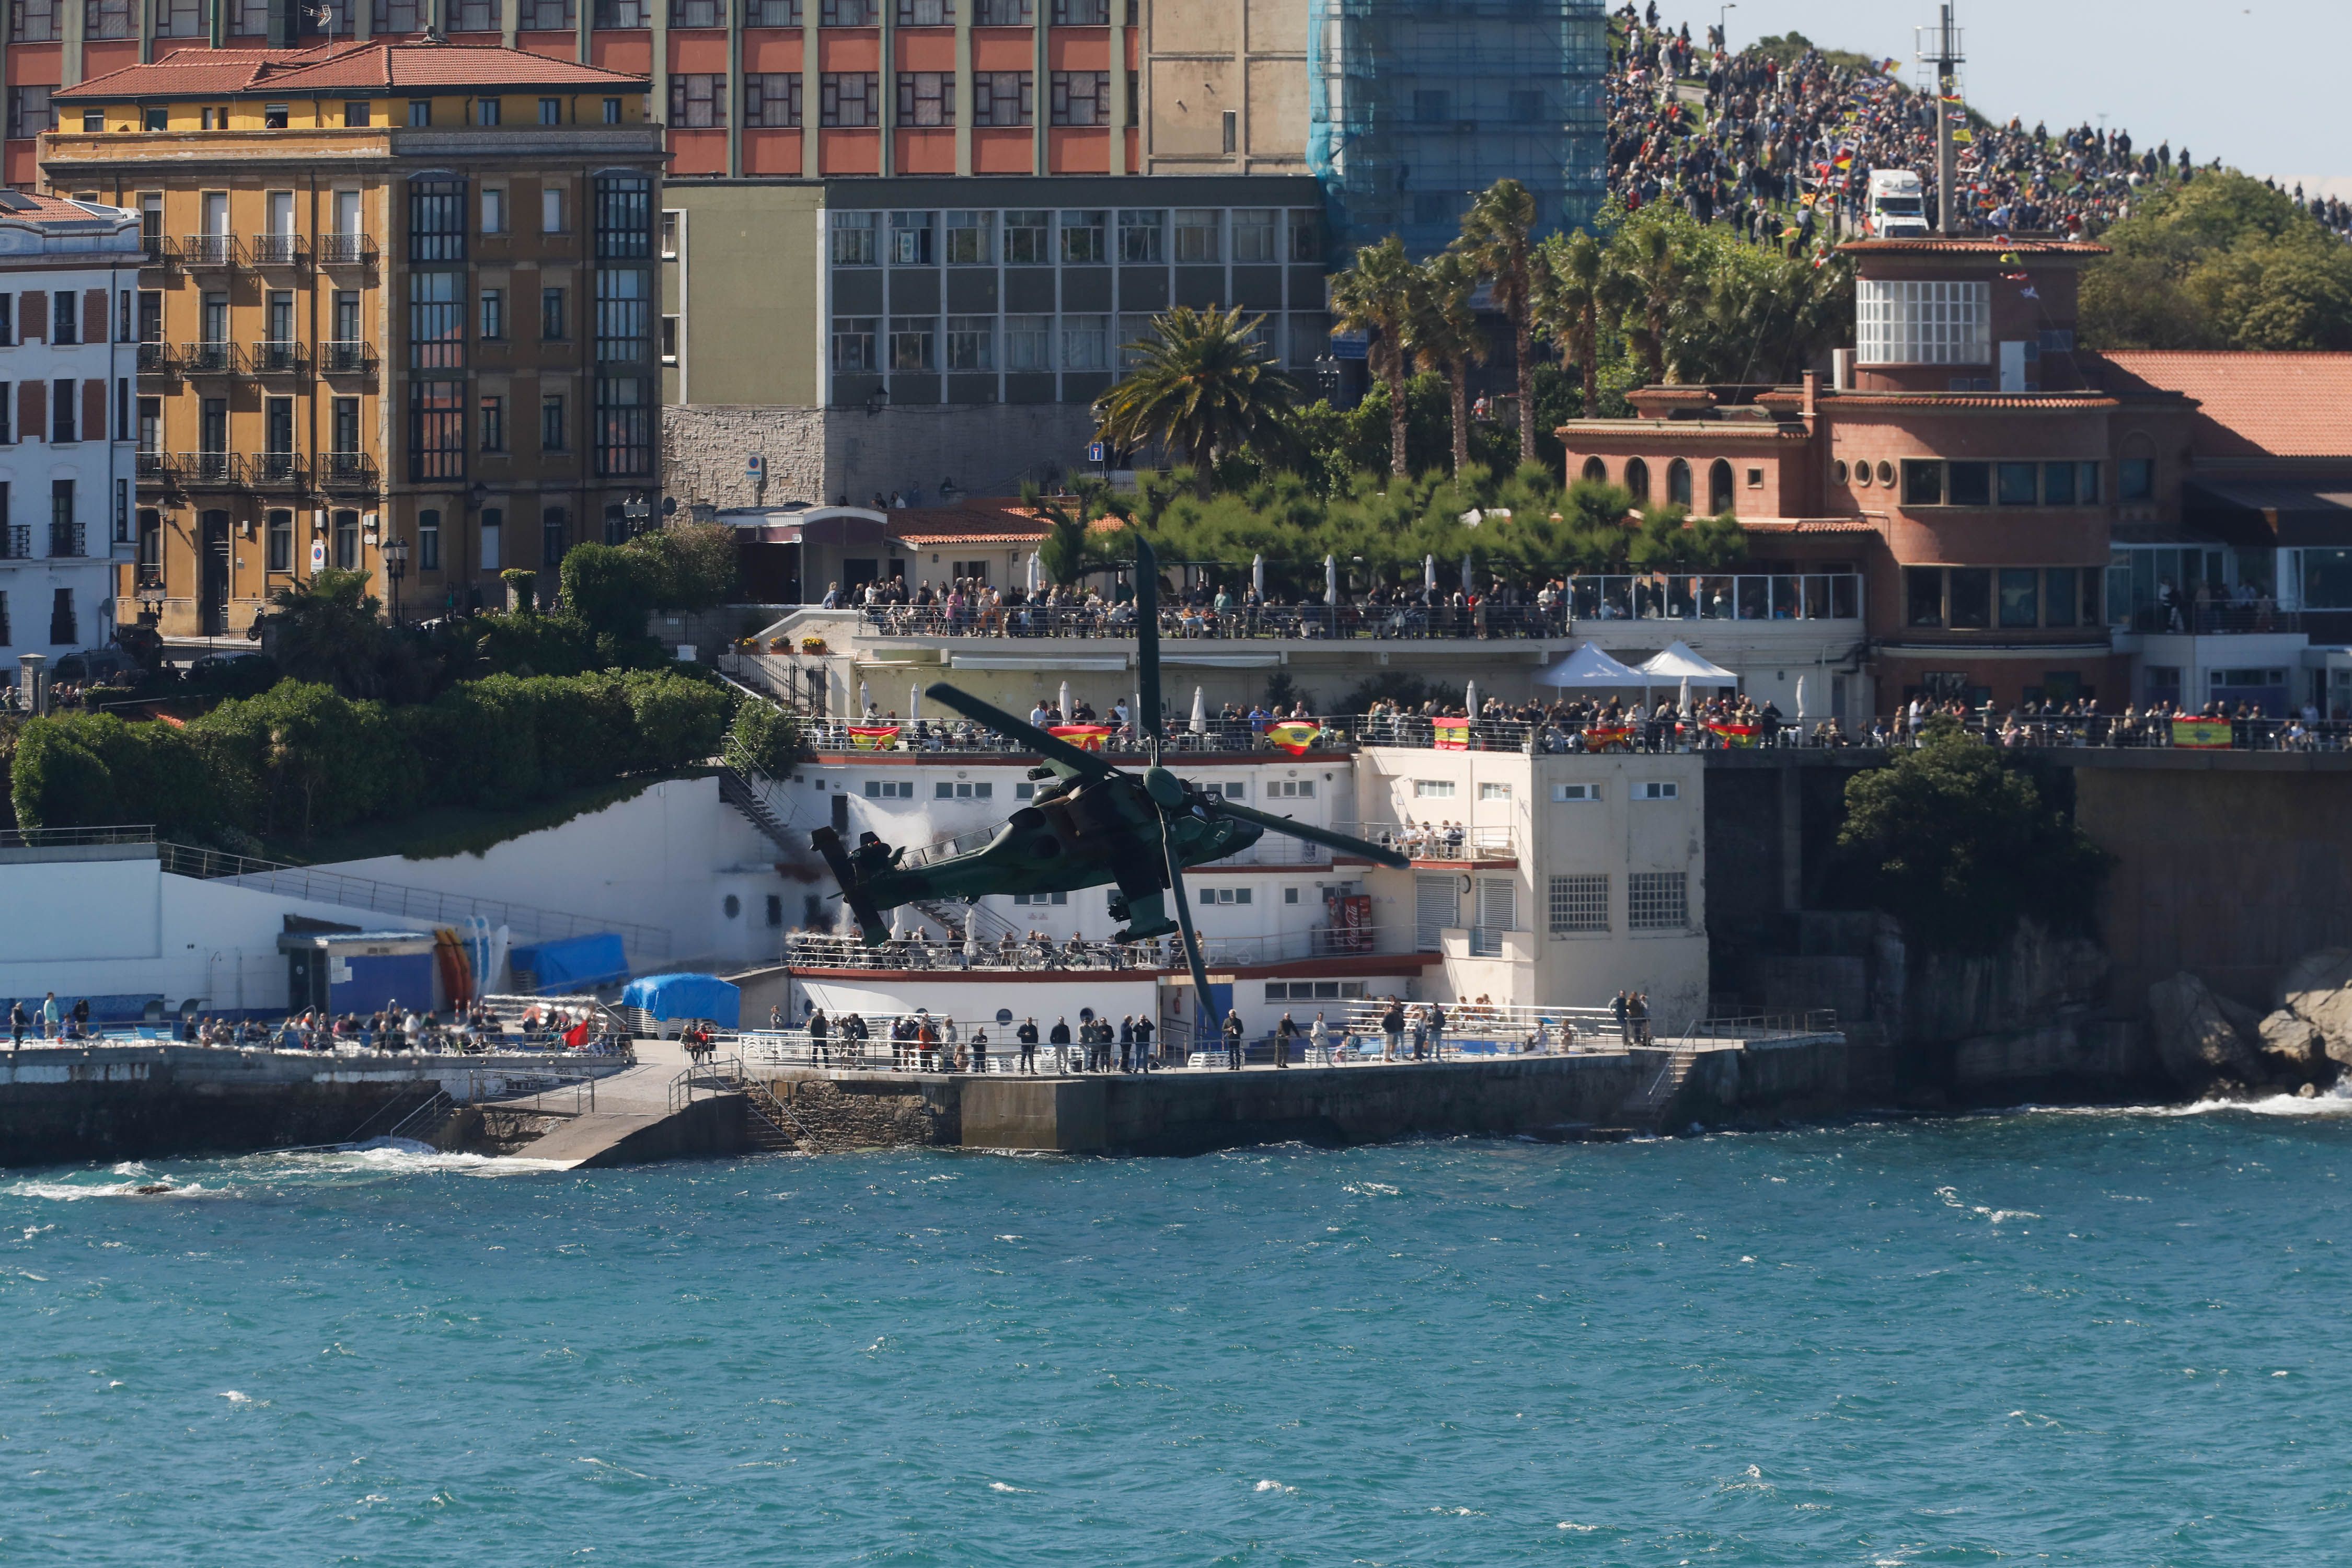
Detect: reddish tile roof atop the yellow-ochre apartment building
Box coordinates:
(50, 40, 649, 101)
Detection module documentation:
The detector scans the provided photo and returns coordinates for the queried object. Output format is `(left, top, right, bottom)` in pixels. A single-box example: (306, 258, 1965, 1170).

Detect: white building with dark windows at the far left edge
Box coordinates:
(0, 193, 141, 682)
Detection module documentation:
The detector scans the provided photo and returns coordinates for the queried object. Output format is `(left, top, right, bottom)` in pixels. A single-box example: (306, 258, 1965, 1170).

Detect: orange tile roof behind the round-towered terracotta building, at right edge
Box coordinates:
(2101, 348, 2352, 458)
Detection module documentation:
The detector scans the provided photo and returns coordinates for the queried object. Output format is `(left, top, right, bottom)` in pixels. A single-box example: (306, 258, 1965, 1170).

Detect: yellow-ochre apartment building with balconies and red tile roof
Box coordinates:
(42, 44, 661, 635)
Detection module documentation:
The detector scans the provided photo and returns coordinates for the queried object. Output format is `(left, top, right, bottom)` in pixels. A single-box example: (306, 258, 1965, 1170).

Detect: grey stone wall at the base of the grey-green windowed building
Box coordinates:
(661, 402, 1094, 508)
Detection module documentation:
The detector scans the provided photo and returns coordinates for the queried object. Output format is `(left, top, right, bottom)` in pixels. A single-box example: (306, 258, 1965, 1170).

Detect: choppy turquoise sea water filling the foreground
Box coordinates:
(0, 1102, 2352, 1568)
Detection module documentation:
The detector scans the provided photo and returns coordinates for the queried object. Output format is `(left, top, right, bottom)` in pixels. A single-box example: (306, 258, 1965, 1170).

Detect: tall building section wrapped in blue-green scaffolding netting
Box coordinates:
(1308, 0, 1609, 256)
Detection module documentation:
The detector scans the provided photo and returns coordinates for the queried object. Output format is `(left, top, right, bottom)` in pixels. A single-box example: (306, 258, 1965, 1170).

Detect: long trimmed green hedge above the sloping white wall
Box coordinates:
(9, 670, 734, 839)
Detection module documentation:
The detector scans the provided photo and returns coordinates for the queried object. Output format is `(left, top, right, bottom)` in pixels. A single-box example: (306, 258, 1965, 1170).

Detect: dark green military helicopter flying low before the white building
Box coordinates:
(809, 538, 1411, 1044)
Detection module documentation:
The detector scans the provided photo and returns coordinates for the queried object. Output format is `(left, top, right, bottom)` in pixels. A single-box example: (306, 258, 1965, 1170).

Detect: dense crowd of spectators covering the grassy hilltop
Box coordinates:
(1607, 0, 2211, 247)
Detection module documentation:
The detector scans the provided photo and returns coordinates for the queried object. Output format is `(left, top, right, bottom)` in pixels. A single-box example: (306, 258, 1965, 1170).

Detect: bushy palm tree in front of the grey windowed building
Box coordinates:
(1094, 306, 1298, 494)
